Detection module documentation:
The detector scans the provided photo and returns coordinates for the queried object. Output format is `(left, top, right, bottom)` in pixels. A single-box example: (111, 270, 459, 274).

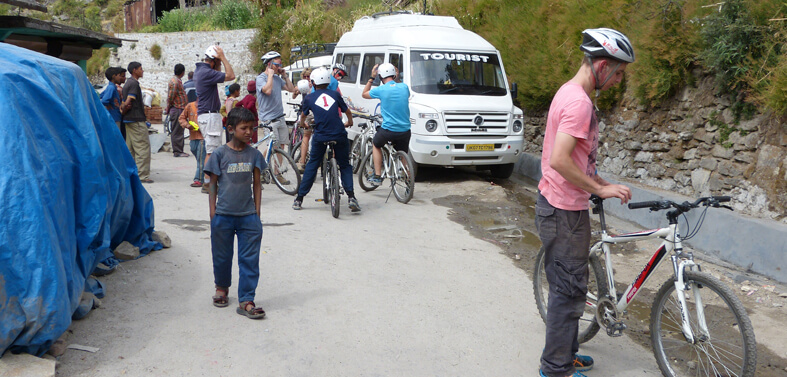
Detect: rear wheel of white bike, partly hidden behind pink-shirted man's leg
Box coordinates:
(533, 248, 609, 343)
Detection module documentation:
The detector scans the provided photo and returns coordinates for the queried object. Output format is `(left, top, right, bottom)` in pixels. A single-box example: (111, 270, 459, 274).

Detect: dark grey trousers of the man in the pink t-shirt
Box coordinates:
(536, 194, 590, 377)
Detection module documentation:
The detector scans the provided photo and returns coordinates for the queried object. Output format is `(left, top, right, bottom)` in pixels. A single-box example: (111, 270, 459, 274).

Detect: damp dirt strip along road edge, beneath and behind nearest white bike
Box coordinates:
(434, 171, 787, 377)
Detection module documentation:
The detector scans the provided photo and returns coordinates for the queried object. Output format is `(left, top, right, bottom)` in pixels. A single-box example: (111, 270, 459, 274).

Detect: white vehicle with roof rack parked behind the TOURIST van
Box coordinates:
(281, 43, 336, 124)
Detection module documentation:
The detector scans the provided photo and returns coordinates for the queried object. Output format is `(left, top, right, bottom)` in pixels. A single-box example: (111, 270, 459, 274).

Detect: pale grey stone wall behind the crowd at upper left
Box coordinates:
(109, 29, 259, 107)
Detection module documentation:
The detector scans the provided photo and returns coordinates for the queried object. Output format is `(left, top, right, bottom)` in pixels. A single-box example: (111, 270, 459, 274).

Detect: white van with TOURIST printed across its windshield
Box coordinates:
(333, 12, 524, 178)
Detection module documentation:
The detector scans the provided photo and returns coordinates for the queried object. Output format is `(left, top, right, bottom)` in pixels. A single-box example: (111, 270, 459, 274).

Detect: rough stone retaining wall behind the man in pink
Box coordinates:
(525, 77, 787, 220)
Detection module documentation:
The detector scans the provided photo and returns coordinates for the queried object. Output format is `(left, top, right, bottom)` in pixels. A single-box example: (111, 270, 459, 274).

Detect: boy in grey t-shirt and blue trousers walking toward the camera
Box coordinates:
(205, 107, 267, 319)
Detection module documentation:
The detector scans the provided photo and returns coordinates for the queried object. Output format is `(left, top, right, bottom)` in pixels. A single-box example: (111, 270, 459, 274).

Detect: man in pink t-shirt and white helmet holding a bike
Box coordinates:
(536, 28, 634, 377)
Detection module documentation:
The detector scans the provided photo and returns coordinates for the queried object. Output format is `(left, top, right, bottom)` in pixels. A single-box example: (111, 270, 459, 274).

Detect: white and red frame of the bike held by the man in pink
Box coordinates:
(587, 203, 710, 343)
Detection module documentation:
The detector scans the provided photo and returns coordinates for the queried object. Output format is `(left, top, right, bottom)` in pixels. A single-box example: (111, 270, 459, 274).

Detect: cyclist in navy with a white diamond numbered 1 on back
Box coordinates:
(292, 69, 361, 212)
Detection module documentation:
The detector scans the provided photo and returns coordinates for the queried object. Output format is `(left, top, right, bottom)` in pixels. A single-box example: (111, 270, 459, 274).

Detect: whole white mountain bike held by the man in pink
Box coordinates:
(533, 195, 757, 377)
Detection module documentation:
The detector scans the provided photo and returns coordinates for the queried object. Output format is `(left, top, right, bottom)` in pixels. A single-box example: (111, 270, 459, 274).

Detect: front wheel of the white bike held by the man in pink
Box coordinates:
(650, 271, 757, 377)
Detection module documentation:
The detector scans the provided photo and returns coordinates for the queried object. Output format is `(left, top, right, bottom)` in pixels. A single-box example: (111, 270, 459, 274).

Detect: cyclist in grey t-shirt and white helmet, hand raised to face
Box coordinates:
(257, 51, 295, 182)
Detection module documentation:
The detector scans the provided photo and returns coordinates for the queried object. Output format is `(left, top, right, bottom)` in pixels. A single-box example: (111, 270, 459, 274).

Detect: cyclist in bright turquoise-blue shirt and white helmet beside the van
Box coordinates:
(362, 63, 410, 186)
